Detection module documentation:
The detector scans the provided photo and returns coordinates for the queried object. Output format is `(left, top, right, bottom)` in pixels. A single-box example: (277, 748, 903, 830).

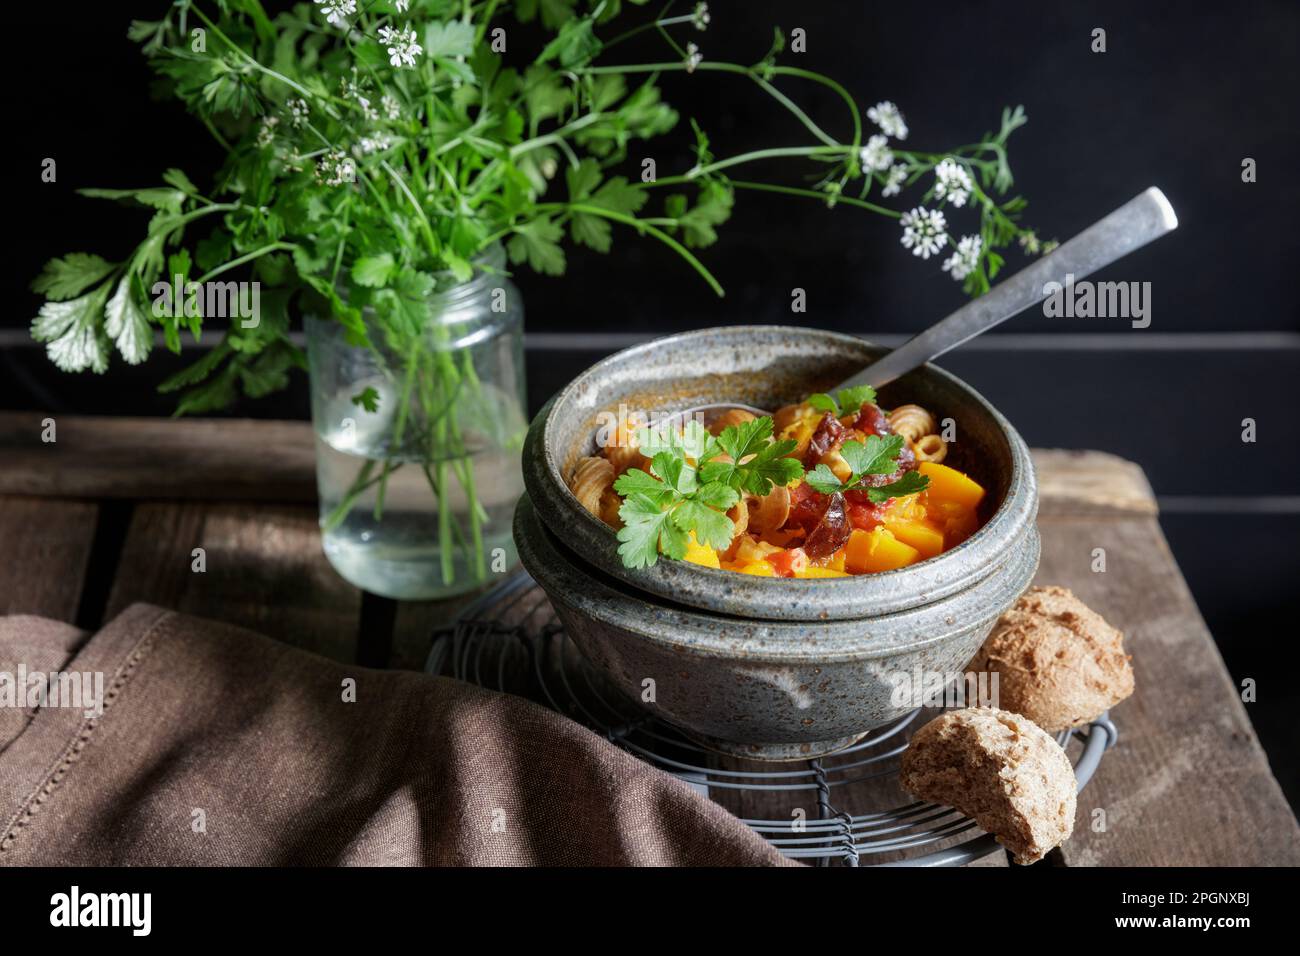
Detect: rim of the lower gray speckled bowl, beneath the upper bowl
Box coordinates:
(514, 494, 1041, 666)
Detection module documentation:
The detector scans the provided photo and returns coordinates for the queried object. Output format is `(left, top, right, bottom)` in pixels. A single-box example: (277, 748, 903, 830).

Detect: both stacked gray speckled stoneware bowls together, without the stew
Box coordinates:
(515, 326, 1039, 760)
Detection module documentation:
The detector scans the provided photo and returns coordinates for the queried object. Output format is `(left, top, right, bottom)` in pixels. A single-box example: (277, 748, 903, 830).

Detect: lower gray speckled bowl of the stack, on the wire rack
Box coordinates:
(515, 497, 1039, 760)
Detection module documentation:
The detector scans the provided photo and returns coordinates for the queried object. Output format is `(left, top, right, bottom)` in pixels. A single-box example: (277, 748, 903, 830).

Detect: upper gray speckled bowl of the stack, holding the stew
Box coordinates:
(524, 325, 1037, 620)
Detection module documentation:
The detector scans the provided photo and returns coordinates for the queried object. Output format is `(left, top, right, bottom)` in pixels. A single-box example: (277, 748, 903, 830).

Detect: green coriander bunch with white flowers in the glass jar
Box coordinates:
(33, 0, 1045, 595)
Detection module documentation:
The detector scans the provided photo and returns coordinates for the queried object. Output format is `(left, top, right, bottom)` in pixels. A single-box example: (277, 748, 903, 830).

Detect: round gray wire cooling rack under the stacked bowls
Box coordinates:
(425, 571, 1118, 866)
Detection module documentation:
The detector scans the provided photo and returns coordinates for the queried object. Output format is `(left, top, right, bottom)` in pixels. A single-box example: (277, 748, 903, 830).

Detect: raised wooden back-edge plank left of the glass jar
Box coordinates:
(0, 412, 316, 501)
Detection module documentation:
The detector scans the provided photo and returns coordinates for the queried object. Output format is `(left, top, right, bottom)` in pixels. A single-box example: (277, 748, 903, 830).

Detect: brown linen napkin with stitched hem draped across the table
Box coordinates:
(0, 605, 787, 865)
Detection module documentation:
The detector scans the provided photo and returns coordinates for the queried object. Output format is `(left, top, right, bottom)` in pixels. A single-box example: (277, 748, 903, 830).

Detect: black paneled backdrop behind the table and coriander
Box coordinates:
(0, 0, 1300, 804)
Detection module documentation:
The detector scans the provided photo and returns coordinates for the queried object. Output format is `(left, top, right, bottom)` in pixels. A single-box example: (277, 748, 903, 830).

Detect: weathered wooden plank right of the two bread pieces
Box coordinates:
(1037, 516, 1300, 866)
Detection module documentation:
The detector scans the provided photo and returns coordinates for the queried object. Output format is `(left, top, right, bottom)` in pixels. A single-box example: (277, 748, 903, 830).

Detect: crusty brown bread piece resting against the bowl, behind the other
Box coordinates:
(967, 587, 1134, 734)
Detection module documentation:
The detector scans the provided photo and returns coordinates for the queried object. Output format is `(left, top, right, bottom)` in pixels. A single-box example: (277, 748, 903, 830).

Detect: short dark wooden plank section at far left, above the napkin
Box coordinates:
(0, 496, 99, 623)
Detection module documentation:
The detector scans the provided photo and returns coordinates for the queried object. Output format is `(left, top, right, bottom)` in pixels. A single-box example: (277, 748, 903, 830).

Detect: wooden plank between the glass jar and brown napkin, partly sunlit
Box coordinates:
(108, 502, 361, 662)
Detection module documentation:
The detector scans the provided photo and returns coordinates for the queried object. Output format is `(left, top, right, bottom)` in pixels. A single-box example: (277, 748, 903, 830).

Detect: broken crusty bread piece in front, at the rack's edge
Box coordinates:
(900, 708, 1076, 864)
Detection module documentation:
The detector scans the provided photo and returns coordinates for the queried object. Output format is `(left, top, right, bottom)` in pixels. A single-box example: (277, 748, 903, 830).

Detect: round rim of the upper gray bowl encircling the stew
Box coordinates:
(524, 325, 1037, 620)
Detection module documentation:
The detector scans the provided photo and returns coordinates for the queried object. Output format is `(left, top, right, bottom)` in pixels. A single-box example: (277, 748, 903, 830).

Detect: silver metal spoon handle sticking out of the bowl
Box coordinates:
(841, 186, 1178, 388)
